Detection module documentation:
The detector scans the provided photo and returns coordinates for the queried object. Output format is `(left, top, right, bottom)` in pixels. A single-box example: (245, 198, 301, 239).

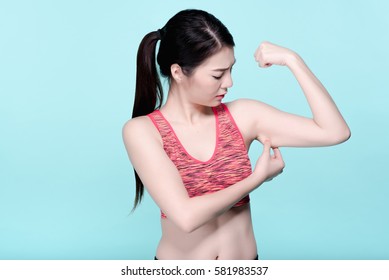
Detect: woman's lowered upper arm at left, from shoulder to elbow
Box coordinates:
(123, 117, 189, 223)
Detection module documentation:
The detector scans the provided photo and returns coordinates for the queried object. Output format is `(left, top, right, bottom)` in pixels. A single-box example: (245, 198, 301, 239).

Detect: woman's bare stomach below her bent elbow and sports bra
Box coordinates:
(156, 204, 257, 260)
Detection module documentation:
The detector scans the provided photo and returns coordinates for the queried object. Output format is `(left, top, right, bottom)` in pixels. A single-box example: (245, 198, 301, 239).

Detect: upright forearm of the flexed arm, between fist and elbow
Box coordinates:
(287, 53, 350, 138)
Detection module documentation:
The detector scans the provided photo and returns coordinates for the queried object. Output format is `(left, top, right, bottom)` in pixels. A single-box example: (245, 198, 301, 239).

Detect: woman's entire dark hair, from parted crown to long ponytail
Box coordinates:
(132, 9, 235, 210)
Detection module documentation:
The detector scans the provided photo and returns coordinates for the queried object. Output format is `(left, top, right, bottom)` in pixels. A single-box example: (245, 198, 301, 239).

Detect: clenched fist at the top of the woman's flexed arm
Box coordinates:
(254, 41, 297, 68)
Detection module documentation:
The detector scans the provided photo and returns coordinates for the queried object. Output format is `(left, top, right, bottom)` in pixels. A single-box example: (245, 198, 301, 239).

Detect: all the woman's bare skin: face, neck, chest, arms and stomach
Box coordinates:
(123, 42, 350, 259)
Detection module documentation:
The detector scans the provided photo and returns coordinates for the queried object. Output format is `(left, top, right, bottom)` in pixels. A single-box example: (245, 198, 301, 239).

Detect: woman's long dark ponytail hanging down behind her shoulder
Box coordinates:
(132, 31, 163, 210)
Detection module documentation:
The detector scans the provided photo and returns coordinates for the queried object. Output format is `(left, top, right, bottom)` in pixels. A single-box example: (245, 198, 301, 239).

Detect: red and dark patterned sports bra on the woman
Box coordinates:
(148, 104, 252, 218)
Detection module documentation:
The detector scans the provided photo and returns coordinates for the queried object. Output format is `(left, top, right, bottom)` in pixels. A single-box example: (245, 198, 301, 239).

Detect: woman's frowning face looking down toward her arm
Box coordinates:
(178, 47, 235, 107)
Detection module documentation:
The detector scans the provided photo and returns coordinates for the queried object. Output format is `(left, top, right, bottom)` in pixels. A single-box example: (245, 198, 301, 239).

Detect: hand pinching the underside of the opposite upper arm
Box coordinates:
(253, 140, 285, 182)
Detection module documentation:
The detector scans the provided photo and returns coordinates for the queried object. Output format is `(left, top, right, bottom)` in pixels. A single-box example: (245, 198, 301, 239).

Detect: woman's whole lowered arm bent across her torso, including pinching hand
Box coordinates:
(123, 117, 284, 232)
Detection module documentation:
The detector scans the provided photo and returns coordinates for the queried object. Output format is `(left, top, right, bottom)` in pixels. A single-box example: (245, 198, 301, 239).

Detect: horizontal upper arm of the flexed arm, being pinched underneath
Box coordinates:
(230, 99, 346, 147)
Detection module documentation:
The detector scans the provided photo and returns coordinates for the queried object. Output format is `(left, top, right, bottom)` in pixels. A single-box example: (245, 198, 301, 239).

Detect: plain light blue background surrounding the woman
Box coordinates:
(0, 0, 389, 259)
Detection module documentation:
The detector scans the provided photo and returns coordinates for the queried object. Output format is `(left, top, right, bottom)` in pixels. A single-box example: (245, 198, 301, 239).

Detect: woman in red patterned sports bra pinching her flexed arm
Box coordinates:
(123, 10, 350, 259)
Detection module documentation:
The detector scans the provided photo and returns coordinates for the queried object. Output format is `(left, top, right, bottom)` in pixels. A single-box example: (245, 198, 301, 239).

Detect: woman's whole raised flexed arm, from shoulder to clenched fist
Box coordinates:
(235, 42, 350, 147)
